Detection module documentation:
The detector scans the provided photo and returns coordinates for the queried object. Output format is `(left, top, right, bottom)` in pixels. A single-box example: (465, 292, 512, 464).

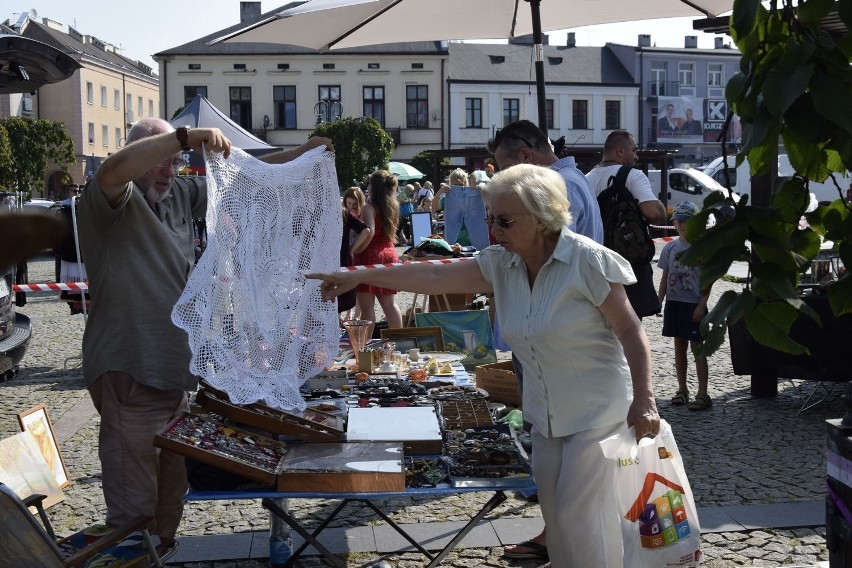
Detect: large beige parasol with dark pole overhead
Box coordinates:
(210, 0, 733, 132)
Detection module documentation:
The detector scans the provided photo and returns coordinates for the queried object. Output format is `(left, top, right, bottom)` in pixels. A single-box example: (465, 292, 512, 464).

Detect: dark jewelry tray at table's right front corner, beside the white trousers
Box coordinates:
(443, 424, 532, 487)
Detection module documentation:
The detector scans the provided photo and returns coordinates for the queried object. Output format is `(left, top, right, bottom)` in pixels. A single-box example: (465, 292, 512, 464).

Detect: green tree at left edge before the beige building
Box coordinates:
(0, 116, 76, 194)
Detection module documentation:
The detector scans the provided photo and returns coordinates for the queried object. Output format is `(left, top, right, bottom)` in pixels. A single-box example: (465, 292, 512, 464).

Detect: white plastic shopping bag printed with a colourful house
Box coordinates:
(600, 420, 702, 568)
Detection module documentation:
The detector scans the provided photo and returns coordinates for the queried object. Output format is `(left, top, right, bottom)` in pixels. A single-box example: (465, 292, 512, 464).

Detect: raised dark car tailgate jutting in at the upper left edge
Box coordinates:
(0, 34, 80, 94)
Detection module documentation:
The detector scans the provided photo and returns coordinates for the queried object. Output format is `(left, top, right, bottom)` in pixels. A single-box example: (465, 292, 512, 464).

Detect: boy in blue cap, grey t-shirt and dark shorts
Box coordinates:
(657, 201, 713, 410)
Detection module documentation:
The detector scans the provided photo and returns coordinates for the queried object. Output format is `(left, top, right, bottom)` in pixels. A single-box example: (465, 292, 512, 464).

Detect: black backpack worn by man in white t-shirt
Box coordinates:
(598, 166, 654, 264)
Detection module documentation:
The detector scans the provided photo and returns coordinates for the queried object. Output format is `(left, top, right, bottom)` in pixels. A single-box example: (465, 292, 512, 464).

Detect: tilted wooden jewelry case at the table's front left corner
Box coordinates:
(154, 413, 288, 485)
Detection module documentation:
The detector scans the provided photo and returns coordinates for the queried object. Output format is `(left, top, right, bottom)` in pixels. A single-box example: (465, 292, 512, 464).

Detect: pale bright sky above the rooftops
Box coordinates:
(18, 0, 730, 69)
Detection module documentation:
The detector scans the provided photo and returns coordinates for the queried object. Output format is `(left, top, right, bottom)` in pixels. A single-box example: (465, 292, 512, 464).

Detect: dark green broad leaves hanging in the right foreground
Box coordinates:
(684, 0, 852, 354)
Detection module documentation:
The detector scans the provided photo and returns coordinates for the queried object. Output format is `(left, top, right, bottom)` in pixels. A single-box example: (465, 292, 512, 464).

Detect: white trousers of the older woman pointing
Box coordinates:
(531, 424, 624, 568)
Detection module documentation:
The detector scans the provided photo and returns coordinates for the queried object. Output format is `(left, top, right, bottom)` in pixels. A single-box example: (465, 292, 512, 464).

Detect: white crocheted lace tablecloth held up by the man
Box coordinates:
(172, 148, 343, 410)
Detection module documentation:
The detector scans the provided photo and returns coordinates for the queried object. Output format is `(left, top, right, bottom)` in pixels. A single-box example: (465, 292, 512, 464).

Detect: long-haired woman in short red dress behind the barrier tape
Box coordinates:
(355, 170, 402, 336)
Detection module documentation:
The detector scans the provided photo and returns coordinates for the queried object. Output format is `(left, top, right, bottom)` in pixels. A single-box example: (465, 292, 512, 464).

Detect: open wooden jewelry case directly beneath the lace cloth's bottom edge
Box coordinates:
(195, 383, 345, 442)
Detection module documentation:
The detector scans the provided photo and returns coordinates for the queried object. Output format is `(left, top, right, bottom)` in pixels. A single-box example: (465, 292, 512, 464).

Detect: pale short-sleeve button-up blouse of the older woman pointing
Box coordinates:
(477, 228, 636, 437)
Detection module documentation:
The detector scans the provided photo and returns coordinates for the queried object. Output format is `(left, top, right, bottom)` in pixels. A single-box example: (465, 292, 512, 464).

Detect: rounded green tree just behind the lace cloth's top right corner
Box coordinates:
(311, 117, 394, 188)
